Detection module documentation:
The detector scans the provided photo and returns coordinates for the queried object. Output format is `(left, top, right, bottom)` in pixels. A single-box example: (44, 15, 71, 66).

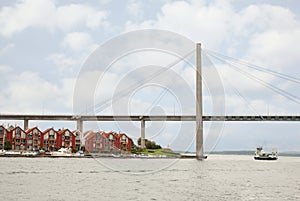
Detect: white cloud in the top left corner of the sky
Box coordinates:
(0, 0, 107, 36)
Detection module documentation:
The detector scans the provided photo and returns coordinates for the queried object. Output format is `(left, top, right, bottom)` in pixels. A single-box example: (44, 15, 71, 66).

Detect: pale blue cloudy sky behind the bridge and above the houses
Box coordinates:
(0, 0, 300, 151)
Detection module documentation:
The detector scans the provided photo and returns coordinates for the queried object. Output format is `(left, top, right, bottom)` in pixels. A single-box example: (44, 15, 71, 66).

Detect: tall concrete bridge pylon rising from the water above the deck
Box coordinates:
(196, 43, 204, 160)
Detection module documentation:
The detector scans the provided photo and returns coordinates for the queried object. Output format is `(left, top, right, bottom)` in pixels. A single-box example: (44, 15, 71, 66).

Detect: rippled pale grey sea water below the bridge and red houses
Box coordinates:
(0, 155, 300, 201)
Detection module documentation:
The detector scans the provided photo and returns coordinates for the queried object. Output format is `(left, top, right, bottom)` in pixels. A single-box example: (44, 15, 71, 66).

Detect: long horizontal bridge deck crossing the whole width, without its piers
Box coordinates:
(0, 114, 300, 122)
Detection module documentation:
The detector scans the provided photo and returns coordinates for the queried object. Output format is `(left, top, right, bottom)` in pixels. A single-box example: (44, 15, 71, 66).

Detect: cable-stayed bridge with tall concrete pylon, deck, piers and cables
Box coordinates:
(0, 43, 300, 160)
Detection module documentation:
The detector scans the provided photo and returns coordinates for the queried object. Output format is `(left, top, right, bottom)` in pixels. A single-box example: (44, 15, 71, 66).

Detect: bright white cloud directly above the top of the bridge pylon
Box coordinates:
(127, 1, 233, 49)
